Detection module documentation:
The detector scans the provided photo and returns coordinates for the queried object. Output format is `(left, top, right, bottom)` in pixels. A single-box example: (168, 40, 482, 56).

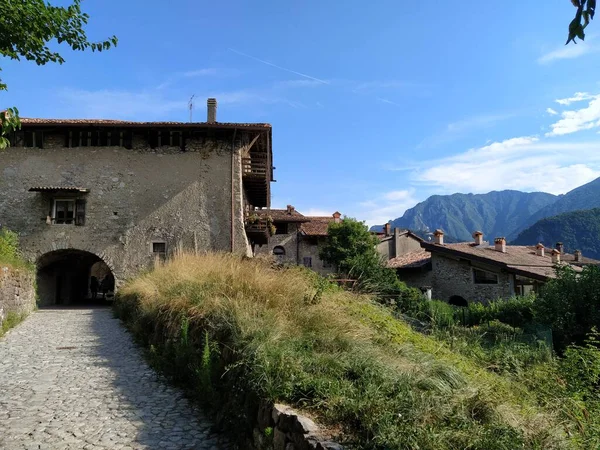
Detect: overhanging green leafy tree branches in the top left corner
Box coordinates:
(0, 0, 117, 149)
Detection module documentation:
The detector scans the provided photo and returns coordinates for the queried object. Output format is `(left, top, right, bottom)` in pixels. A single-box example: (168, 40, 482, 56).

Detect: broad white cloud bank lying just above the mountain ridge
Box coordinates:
(414, 136, 600, 194)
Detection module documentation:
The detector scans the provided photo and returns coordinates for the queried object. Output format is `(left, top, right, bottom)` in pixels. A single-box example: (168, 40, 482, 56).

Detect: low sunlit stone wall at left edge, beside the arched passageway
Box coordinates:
(0, 266, 35, 328)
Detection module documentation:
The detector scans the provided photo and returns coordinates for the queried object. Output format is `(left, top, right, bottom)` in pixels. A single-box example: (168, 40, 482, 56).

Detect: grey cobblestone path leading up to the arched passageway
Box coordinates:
(0, 308, 227, 450)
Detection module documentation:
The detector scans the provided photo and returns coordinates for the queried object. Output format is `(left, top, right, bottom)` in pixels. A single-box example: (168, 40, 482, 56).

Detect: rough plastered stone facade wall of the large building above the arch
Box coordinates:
(0, 134, 250, 280)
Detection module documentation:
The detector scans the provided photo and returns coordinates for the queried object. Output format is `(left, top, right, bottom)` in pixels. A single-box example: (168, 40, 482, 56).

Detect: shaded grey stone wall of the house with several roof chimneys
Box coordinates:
(431, 253, 514, 303)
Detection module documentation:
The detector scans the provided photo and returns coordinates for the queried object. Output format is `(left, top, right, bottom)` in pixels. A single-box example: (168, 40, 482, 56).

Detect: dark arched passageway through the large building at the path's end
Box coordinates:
(37, 249, 115, 306)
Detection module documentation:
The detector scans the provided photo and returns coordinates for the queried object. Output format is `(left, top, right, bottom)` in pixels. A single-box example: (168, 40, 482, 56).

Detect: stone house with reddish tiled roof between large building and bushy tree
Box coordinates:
(255, 205, 342, 275)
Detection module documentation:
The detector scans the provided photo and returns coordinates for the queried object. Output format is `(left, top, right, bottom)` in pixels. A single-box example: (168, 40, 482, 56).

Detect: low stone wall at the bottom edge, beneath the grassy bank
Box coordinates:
(254, 402, 343, 450)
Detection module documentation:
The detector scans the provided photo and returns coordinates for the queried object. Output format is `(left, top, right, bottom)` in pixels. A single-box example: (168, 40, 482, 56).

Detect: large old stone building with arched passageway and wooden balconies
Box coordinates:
(0, 99, 273, 304)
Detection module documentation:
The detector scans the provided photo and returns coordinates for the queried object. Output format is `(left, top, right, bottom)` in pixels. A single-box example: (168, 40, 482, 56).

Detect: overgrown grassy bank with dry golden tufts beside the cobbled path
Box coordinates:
(116, 254, 592, 450)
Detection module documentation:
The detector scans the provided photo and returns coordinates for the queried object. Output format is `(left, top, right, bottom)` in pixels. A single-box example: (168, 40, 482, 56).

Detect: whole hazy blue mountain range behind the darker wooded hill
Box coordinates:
(374, 178, 600, 246)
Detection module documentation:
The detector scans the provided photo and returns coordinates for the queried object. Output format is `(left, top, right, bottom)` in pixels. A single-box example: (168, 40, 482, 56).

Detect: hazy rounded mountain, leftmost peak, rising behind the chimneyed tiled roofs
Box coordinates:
(378, 190, 557, 241)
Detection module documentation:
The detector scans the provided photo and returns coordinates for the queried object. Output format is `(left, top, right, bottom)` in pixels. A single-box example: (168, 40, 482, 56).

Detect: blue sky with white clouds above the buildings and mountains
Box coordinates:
(0, 0, 600, 224)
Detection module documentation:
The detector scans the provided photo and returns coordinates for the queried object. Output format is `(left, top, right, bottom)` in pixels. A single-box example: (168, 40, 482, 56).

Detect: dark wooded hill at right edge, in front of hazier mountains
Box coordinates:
(513, 208, 600, 259)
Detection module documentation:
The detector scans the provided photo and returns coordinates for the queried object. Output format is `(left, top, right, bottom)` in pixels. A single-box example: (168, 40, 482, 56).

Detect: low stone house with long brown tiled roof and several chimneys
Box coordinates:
(421, 230, 600, 306)
